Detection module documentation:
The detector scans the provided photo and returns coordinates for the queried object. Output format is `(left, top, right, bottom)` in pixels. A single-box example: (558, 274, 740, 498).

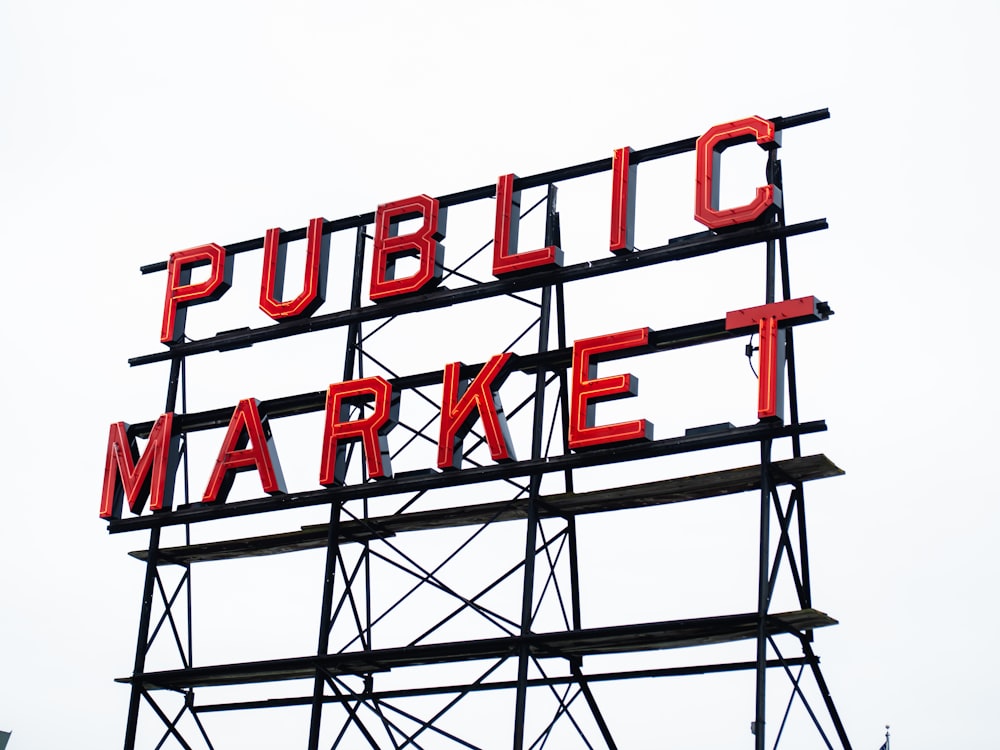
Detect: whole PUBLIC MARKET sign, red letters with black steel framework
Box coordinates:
(100, 110, 850, 750)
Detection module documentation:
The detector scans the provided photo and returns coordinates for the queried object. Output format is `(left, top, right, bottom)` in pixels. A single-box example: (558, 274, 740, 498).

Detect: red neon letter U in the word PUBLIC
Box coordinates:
(260, 218, 330, 320)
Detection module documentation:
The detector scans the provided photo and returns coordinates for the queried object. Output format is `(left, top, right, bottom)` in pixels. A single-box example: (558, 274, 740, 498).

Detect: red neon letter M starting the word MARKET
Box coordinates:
(101, 412, 180, 518)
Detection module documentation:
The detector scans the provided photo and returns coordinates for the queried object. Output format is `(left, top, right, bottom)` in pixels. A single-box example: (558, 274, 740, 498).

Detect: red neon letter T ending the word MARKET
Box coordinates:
(726, 297, 819, 419)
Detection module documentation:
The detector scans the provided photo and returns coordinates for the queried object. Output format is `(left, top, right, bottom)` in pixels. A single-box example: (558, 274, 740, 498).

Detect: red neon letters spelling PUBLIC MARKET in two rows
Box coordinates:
(100, 117, 828, 522)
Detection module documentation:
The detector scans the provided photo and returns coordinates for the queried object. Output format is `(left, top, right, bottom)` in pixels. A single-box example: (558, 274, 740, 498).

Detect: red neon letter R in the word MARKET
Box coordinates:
(319, 376, 399, 487)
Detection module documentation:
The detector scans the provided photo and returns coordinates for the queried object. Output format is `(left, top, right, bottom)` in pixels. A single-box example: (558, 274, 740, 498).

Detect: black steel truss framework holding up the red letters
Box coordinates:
(110, 111, 851, 750)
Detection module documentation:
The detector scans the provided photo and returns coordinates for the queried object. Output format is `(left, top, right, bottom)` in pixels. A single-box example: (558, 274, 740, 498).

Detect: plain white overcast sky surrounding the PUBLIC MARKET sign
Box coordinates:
(0, 0, 1000, 750)
